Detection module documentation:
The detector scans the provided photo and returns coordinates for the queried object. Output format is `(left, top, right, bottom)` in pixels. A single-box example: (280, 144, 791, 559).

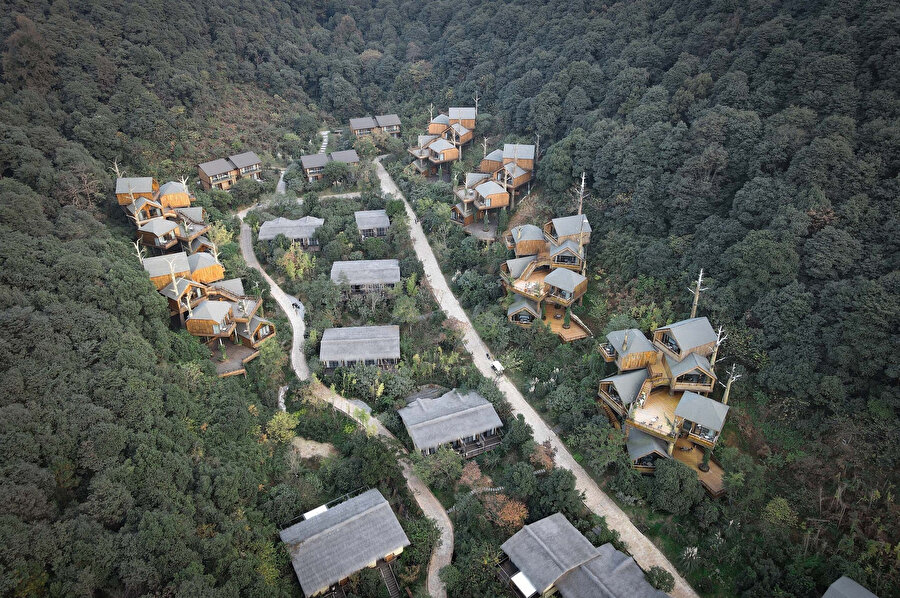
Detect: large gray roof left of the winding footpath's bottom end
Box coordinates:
(278, 489, 409, 596)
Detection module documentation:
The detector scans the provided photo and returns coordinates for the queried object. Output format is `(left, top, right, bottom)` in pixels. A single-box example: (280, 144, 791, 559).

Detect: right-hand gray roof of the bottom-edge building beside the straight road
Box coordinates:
(556, 544, 668, 598)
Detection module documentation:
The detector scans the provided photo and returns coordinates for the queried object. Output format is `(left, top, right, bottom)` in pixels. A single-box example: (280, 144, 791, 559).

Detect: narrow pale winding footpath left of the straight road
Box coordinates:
(237, 175, 453, 598)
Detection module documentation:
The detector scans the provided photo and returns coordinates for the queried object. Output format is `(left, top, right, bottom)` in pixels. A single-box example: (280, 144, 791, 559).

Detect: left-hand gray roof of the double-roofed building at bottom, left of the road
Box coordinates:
(500, 513, 597, 593)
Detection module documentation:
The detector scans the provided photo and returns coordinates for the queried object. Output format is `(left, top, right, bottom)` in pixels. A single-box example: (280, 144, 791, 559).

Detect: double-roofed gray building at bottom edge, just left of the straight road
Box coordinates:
(499, 513, 667, 598)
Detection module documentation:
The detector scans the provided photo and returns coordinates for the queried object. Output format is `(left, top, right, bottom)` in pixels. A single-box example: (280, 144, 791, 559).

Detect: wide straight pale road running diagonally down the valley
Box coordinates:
(376, 158, 699, 598)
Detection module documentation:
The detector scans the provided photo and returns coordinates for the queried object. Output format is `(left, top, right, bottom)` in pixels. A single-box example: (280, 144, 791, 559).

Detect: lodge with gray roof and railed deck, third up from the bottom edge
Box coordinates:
(397, 389, 503, 459)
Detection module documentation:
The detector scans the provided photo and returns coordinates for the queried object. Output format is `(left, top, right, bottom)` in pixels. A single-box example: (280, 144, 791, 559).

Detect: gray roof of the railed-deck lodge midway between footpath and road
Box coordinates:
(397, 388, 503, 451)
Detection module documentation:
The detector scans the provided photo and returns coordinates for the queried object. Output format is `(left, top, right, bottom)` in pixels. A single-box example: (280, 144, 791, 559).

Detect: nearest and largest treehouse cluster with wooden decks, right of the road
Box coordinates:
(597, 317, 730, 496)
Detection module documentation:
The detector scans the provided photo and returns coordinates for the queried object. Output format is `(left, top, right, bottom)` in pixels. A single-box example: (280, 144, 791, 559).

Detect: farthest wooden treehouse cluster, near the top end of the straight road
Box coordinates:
(408, 107, 478, 176)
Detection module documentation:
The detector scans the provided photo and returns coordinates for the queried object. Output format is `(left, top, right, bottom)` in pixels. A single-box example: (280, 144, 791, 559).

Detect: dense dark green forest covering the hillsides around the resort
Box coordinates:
(0, 0, 900, 596)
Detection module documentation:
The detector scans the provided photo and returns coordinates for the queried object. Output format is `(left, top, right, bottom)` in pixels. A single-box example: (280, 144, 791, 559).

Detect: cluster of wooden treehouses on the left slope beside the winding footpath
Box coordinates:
(116, 177, 275, 376)
